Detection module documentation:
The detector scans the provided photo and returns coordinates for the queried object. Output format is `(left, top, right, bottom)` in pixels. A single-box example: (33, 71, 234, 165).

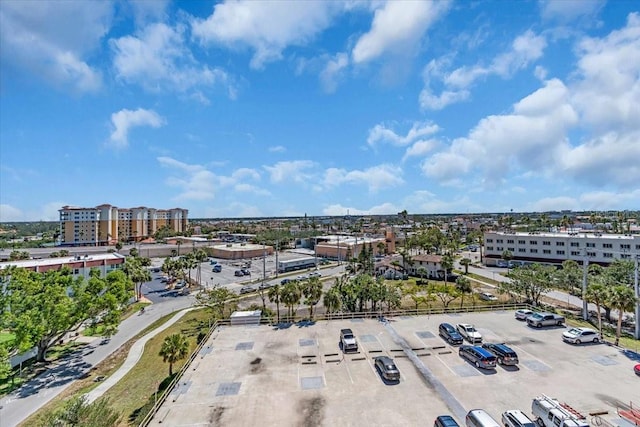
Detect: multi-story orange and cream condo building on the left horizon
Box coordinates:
(59, 204, 189, 246)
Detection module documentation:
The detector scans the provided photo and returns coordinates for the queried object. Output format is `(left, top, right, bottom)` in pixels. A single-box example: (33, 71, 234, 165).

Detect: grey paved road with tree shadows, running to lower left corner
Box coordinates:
(0, 290, 193, 427)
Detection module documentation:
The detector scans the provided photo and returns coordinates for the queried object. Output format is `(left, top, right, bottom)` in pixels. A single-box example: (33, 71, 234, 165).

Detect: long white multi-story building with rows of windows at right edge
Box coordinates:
(484, 232, 640, 265)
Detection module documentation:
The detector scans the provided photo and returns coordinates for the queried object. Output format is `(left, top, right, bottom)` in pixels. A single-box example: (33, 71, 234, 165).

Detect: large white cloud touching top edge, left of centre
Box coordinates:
(191, 0, 343, 68)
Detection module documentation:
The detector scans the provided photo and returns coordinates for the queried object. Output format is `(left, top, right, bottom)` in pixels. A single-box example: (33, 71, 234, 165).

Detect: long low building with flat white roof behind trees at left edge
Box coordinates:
(0, 253, 125, 278)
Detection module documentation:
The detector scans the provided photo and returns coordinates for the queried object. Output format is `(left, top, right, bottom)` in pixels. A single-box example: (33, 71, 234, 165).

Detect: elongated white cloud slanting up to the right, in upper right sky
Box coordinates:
(419, 30, 547, 110)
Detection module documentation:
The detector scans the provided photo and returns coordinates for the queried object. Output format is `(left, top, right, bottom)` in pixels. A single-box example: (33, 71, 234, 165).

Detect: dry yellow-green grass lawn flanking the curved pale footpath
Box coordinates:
(22, 310, 210, 426)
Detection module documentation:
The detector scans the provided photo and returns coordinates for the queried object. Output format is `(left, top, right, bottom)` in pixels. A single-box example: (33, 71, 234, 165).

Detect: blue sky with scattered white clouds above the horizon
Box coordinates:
(0, 0, 640, 221)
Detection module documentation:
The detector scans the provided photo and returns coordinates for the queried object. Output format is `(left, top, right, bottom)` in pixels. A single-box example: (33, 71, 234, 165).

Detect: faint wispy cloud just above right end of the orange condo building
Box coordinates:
(157, 157, 216, 201)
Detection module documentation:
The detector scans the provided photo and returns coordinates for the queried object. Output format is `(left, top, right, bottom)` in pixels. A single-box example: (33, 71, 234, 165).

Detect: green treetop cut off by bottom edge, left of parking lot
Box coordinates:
(46, 396, 122, 427)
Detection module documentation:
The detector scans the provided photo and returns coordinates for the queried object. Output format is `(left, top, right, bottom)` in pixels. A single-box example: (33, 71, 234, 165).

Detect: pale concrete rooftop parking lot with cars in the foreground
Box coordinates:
(152, 312, 640, 426)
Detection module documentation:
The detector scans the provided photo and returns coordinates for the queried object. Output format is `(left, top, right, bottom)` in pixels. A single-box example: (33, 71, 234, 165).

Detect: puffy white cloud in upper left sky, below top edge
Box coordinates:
(111, 23, 237, 100)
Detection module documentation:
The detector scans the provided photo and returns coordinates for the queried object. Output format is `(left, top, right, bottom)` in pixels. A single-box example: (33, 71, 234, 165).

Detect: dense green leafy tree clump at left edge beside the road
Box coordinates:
(0, 268, 131, 361)
